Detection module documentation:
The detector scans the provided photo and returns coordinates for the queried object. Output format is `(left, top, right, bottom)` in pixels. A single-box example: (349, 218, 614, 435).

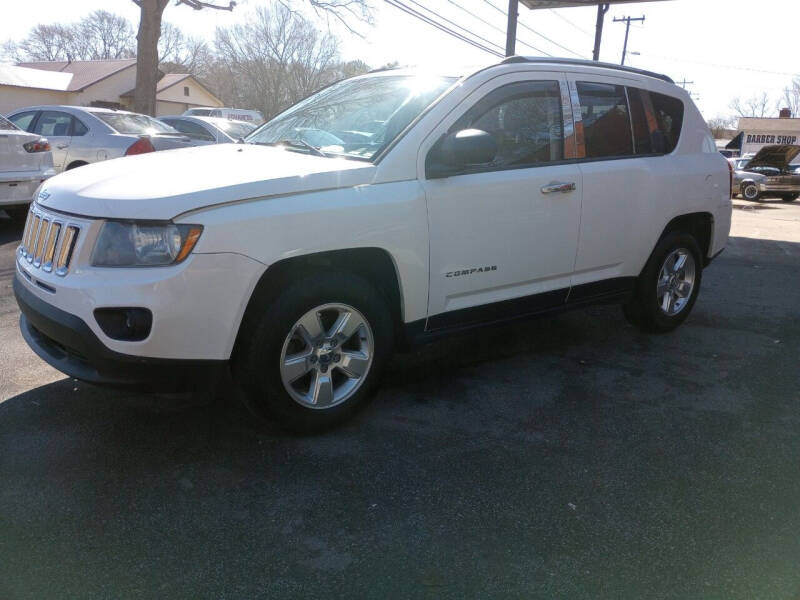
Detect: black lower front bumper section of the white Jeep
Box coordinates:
(14, 275, 228, 392)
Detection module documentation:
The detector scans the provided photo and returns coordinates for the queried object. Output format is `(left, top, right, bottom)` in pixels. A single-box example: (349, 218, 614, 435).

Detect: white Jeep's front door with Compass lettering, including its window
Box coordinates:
(423, 72, 582, 330)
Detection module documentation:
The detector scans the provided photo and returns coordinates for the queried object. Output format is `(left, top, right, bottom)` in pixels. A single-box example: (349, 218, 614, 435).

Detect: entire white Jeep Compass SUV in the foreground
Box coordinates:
(14, 57, 731, 431)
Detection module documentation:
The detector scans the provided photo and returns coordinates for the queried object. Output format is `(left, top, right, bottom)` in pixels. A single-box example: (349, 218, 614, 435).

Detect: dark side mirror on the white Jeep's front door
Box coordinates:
(426, 129, 497, 178)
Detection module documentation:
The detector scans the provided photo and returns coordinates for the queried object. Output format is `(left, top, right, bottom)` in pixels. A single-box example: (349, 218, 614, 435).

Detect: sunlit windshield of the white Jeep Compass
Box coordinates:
(246, 75, 456, 160)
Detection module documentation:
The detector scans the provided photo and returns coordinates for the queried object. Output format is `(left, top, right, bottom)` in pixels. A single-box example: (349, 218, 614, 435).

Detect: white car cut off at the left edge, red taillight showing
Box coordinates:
(0, 116, 56, 219)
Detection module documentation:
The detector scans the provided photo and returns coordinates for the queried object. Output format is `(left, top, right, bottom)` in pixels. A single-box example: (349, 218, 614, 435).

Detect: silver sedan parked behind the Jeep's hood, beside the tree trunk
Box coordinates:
(8, 106, 195, 172)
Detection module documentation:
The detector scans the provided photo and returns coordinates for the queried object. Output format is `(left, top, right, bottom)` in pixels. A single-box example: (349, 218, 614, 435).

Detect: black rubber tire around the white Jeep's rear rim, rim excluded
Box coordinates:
(623, 231, 703, 333)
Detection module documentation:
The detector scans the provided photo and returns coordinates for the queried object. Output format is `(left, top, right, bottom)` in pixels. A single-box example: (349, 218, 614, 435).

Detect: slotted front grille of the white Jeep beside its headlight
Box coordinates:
(19, 206, 80, 277)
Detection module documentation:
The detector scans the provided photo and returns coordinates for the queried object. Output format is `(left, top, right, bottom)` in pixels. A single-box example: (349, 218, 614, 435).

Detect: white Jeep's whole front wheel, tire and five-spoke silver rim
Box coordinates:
(236, 272, 393, 433)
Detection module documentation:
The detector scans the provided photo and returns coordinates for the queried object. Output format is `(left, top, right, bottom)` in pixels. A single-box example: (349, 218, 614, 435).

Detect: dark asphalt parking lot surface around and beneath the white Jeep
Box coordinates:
(0, 201, 800, 600)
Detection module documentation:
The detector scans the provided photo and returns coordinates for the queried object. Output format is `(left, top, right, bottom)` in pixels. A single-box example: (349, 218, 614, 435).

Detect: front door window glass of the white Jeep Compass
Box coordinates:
(454, 81, 564, 169)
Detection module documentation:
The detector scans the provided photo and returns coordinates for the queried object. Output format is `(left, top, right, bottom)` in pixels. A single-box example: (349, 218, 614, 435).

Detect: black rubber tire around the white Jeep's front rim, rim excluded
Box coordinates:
(234, 272, 394, 433)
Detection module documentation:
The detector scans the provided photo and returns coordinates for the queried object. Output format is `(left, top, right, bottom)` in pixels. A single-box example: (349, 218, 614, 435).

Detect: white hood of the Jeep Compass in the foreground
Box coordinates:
(37, 144, 375, 220)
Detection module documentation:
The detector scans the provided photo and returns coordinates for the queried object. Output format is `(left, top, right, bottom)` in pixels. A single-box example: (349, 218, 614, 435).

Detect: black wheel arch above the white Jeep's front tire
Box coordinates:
(233, 247, 404, 357)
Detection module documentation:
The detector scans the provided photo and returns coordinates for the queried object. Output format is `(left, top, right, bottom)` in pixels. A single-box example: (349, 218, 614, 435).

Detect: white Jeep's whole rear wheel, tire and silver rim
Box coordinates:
(623, 232, 703, 333)
